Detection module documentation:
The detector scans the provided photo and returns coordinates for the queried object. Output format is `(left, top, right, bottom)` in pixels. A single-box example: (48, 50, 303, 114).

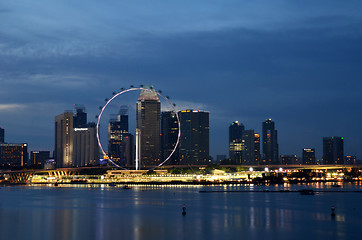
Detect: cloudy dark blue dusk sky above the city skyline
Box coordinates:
(0, 0, 362, 158)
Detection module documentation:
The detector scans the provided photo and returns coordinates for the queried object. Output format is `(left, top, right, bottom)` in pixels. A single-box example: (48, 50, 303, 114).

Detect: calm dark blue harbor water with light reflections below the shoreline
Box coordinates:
(0, 183, 362, 240)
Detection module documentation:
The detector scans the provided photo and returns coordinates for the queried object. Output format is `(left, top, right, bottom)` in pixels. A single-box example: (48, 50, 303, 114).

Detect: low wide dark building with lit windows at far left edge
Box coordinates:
(0, 143, 28, 167)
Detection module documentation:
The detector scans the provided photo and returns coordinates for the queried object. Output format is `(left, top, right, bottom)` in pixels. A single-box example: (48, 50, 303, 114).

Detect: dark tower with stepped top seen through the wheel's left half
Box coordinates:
(108, 106, 134, 166)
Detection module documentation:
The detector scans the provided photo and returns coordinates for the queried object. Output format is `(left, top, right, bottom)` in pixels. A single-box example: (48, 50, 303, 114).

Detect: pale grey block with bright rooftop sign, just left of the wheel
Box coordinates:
(72, 123, 99, 167)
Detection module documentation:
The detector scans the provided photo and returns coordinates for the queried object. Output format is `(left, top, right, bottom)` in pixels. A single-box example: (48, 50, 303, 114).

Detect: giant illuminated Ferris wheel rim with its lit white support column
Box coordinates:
(96, 85, 181, 170)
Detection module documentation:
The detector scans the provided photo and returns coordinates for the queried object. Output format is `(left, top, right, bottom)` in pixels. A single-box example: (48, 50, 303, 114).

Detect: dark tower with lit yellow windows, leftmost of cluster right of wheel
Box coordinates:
(229, 121, 245, 164)
